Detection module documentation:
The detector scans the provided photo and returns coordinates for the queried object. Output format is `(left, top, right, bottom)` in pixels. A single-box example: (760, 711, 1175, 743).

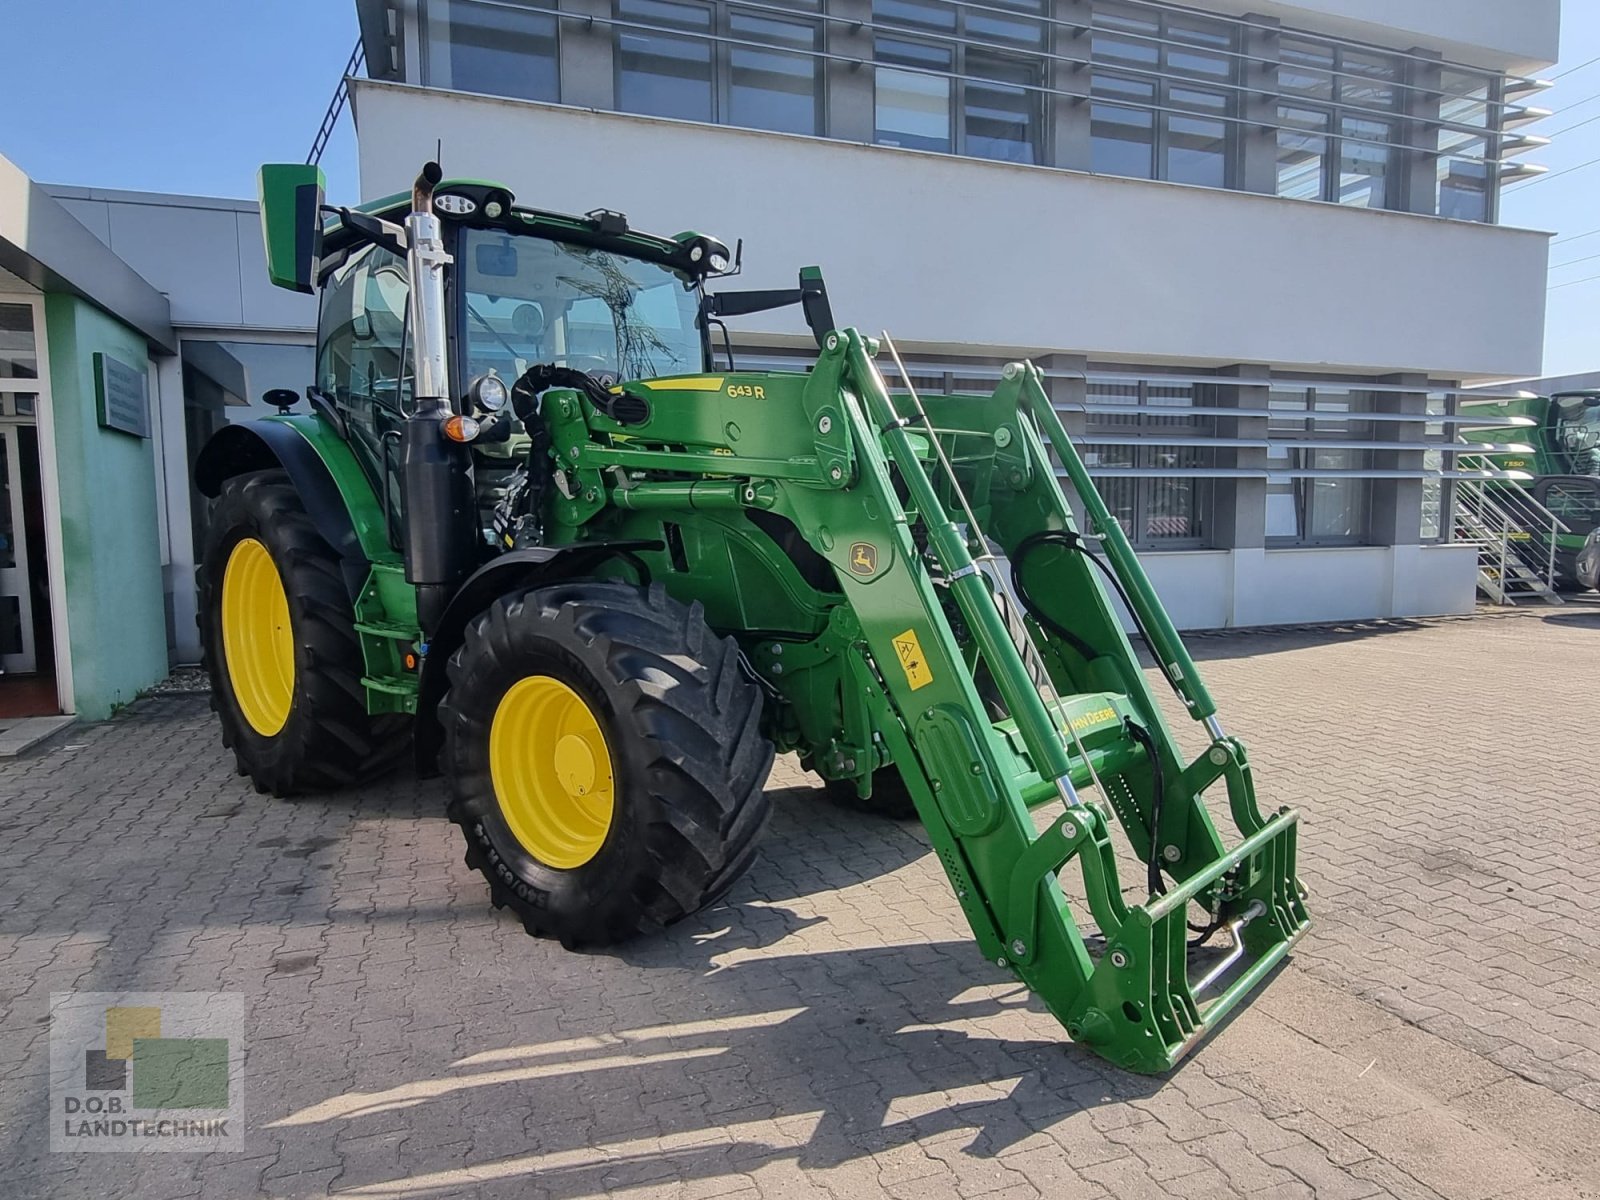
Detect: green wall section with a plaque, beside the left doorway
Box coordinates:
(45, 294, 166, 720)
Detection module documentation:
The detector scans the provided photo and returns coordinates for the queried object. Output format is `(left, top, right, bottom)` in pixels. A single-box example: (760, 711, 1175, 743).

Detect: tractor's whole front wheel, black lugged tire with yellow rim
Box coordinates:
(438, 581, 773, 949)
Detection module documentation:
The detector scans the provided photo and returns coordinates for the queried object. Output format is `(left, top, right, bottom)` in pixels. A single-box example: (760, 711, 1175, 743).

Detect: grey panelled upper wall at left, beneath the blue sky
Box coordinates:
(48, 187, 317, 339)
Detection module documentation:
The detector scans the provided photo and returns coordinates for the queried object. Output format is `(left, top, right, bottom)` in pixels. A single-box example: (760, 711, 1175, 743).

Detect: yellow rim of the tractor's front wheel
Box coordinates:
(490, 675, 616, 870)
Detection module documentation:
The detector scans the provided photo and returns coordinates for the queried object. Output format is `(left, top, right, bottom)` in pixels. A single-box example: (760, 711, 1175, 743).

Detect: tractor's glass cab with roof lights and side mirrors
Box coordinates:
(261, 166, 832, 572)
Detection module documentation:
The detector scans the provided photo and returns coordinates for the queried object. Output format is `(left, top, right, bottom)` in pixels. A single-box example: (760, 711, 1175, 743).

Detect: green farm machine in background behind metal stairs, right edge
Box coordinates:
(1461, 390, 1600, 587)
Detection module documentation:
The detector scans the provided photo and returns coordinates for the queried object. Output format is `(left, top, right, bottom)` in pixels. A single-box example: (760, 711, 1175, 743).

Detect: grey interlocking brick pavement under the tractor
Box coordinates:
(0, 606, 1600, 1200)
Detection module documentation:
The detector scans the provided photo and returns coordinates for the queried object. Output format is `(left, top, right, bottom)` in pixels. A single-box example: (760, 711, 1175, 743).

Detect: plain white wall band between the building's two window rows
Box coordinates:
(355, 82, 1547, 378)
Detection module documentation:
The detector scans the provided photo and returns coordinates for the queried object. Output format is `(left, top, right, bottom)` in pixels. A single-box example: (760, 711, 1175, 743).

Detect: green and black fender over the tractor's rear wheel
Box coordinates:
(195, 416, 400, 602)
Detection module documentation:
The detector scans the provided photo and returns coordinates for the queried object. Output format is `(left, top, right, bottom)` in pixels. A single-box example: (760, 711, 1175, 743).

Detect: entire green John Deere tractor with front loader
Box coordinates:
(197, 165, 1307, 1072)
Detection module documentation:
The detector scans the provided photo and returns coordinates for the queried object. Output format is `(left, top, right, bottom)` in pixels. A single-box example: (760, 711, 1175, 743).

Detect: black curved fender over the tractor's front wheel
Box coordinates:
(413, 539, 664, 779)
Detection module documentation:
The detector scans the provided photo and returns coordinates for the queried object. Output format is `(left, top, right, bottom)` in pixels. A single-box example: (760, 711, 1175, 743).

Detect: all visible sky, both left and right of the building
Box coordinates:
(0, 0, 1600, 374)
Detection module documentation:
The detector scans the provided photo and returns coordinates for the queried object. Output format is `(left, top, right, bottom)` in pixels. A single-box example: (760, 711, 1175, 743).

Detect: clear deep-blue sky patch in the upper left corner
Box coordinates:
(0, 0, 358, 203)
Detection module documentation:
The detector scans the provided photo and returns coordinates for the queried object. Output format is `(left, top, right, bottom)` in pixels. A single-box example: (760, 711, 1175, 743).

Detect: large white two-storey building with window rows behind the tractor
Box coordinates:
(352, 0, 1560, 627)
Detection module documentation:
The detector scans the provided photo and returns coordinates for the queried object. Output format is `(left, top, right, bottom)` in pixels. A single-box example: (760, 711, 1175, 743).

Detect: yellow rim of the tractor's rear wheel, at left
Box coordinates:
(222, 538, 294, 738)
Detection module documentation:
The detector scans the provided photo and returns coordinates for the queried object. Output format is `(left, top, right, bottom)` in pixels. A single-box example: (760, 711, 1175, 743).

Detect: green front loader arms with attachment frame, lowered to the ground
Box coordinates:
(790, 330, 1307, 1074)
